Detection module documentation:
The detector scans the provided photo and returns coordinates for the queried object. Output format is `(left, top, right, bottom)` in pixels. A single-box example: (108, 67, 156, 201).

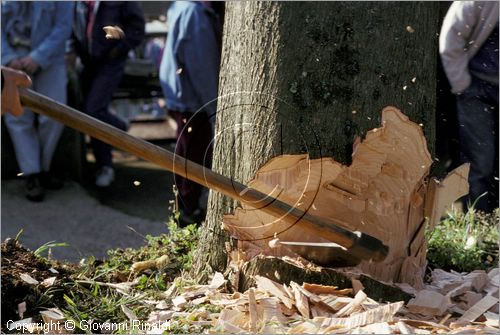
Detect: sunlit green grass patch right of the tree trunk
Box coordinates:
(427, 206, 499, 272)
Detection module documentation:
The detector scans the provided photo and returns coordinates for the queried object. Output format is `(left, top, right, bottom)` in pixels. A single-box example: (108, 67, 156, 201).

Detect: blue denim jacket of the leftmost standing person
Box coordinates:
(2, 1, 74, 69)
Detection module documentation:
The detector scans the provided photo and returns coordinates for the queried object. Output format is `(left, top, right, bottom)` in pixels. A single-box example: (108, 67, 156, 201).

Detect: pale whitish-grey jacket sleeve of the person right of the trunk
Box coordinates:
(439, 1, 478, 93)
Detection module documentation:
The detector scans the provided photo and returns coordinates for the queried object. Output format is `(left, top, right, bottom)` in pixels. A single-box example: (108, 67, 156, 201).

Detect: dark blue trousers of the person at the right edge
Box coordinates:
(457, 77, 498, 212)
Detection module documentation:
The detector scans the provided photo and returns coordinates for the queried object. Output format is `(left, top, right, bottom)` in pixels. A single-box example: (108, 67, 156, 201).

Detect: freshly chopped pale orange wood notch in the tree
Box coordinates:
(223, 107, 468, 288)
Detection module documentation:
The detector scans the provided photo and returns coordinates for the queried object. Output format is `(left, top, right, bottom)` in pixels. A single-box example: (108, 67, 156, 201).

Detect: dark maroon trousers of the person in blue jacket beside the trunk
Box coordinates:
(169, 111, 212, 214)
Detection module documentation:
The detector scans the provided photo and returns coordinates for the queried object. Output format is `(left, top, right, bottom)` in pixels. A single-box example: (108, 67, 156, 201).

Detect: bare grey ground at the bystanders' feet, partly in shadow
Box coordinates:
(1, 148, 177, 262)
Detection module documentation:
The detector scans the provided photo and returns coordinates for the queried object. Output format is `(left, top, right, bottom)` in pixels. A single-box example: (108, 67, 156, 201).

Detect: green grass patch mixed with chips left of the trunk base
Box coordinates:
(16, 211, 201, 333)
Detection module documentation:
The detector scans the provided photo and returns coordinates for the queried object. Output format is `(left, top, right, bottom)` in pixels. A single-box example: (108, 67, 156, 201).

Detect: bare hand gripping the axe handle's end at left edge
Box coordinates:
(1, 66, 31, 116)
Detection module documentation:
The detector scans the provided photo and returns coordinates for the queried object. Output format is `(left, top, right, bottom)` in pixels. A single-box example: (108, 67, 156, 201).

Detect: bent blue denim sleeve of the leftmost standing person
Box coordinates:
(24, 1, 74, 69)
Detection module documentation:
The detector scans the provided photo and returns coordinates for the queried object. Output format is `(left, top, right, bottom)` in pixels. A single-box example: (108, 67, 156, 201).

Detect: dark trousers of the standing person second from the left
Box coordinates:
(82, 60, 127, 167)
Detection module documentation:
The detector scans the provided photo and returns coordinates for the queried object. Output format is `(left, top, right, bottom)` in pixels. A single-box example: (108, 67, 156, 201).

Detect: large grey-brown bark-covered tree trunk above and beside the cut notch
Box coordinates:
(194, 1, 439, 280)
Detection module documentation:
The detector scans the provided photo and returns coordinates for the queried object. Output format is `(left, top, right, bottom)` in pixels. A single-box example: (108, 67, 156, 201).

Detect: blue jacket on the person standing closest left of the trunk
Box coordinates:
(160, 1, 220, 115)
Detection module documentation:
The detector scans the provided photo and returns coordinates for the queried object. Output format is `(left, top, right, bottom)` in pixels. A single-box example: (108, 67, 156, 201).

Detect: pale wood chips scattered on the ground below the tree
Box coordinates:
(4, 262, 499, 334)
